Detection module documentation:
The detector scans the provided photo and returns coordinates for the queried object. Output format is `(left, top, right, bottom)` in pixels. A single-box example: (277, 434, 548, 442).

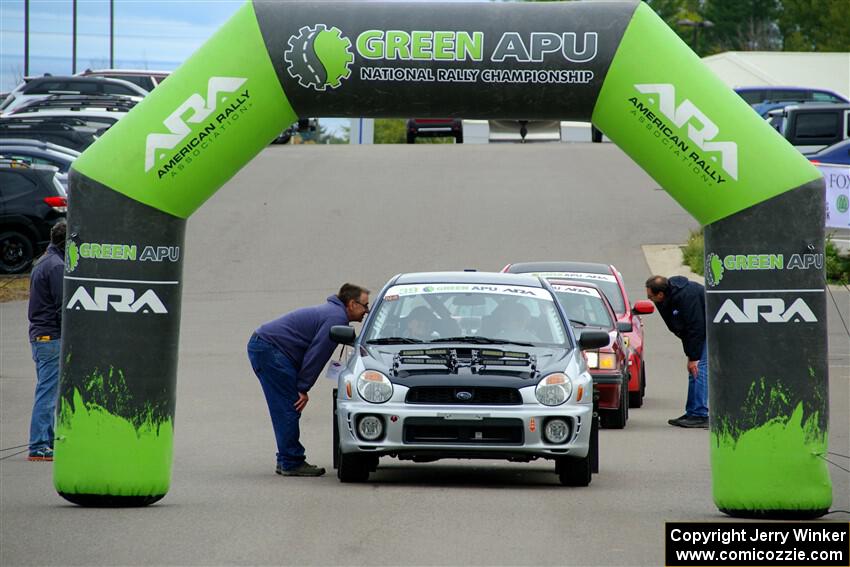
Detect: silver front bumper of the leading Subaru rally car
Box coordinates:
(337, 386, 593, 461)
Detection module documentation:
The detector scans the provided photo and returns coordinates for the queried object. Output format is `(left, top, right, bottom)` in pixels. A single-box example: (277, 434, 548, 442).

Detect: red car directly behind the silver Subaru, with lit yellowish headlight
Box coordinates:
(549, 280, 631, 429)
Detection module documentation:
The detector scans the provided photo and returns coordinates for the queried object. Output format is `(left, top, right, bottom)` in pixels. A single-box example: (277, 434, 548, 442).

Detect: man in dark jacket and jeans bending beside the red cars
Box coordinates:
(646, 276, 708, 428)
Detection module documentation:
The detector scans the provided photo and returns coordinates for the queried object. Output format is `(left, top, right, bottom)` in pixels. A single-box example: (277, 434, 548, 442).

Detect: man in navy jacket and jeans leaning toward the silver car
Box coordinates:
(243, 283, 369, 476)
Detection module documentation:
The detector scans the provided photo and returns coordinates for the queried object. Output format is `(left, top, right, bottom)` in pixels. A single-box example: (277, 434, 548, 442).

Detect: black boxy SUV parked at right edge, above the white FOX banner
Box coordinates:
(767, 104, 850, 154)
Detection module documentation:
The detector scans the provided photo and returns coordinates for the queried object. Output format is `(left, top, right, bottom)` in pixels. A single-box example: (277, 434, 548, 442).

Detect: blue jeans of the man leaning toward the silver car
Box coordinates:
(248, 335, 304, 470)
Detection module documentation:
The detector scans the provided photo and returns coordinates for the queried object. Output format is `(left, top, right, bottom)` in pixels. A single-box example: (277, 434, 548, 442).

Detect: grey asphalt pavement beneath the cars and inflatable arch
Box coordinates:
(0, 144, 850, 566)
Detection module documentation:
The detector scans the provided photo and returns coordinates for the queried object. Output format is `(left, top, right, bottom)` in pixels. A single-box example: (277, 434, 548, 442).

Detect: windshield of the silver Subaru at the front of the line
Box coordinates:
(364, 283, 569, 348)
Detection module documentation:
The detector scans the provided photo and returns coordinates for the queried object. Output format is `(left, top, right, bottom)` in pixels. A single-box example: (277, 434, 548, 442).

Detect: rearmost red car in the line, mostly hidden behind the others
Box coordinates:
(502, 262, 655, 408)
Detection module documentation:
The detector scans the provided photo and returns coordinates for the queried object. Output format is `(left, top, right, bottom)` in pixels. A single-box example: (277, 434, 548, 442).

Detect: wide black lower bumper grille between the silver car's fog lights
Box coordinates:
(404, 417, 524, 445)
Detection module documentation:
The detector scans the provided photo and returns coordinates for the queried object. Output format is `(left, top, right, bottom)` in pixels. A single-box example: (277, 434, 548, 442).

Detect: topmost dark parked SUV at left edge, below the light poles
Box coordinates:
(0, 75, 148, 115)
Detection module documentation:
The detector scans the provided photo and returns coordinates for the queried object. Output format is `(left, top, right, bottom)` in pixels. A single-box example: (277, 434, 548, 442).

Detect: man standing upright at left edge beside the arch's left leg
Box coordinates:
(27, 221, 67, 461)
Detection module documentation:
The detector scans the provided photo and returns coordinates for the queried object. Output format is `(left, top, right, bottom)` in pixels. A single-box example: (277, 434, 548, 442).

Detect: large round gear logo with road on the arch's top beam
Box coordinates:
(283, 24, 354, 91)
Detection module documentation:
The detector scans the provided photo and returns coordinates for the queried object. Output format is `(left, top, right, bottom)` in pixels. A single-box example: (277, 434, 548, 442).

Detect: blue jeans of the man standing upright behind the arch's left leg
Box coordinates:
(30, 339, 60, 453)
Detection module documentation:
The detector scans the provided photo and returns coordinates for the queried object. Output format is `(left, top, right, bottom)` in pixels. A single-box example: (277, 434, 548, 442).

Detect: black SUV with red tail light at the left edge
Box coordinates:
(0, 159, 68, 274)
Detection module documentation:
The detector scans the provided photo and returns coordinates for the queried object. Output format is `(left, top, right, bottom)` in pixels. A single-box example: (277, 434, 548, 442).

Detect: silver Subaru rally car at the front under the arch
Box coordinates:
(330, 272, 609, 486)
